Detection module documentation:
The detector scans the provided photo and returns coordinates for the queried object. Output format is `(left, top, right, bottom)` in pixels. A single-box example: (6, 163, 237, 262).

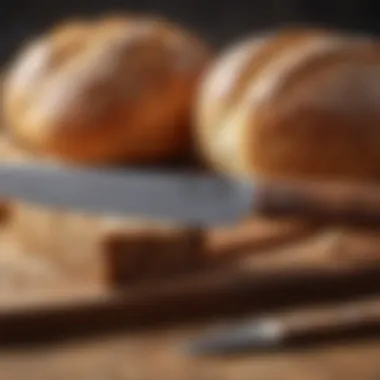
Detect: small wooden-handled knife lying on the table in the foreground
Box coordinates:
(184, 299, 380, 356)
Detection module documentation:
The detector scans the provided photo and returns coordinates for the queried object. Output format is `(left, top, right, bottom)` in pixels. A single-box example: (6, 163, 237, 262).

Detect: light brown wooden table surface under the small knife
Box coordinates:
(0, 331, 380, 380)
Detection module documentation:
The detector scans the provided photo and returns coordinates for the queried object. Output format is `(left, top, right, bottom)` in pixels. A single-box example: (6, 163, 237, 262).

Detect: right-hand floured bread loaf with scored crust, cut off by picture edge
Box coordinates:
(196, 29, 380, 180)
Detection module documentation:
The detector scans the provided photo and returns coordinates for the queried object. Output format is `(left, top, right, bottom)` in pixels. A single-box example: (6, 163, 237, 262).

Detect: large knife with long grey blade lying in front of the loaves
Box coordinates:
(0, 163, 380, 225)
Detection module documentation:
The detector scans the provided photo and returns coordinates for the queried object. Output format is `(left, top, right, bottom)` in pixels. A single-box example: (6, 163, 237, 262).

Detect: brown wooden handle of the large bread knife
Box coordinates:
(256, 182, 380, 225)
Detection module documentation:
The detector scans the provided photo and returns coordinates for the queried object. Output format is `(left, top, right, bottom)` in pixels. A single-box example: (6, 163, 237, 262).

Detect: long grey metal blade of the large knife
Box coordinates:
(0, 163, 254, 225)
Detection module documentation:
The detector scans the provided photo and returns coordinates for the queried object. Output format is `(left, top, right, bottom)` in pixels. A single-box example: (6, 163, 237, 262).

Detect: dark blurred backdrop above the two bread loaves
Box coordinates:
(0, 0, 380, 62)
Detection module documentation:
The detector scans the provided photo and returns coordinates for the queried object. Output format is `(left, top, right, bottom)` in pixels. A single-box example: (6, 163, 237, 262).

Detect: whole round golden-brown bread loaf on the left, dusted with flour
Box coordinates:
(4, 16, 209, 164)
